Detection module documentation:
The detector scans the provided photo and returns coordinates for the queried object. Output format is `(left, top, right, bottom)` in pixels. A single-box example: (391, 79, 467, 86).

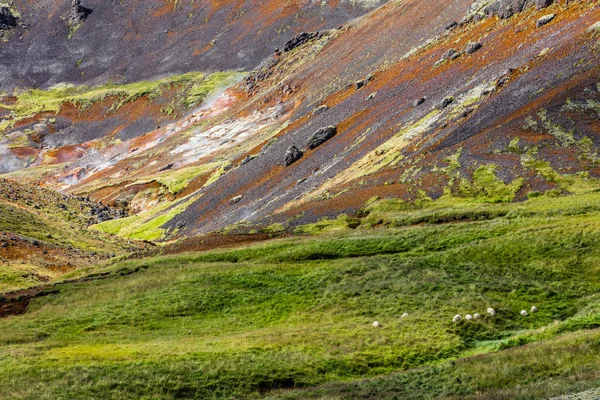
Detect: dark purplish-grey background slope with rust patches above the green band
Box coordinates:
(0, 0, 381, 90)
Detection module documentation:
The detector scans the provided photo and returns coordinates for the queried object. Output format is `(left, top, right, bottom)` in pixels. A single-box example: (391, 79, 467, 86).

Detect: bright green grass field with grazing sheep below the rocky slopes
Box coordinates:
(0, 192, 600, 399)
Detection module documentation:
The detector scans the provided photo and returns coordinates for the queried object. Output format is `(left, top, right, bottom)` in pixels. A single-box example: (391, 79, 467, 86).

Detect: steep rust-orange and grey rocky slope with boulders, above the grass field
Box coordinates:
(57, 1, 600, 237)
